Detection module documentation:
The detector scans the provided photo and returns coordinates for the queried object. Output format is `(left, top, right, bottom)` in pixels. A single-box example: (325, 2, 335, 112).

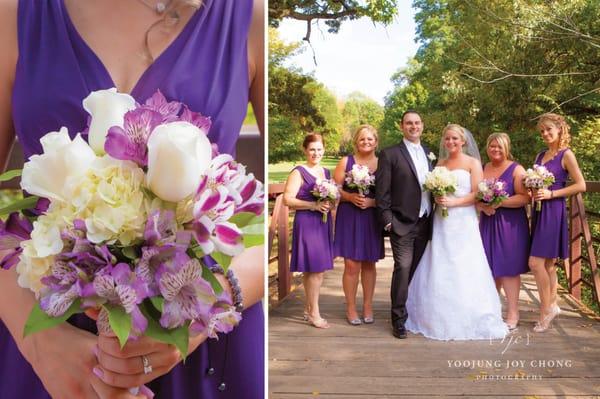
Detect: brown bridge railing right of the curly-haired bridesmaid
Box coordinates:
(564, 182, 600, 305)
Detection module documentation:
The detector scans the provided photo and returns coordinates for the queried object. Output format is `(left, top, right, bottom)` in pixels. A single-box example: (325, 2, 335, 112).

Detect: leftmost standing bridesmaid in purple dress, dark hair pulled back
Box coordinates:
(283, 133, 333, 328)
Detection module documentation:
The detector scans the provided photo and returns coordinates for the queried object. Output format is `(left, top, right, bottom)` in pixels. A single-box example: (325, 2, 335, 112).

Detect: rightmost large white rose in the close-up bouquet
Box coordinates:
(147, 122, 212, 202)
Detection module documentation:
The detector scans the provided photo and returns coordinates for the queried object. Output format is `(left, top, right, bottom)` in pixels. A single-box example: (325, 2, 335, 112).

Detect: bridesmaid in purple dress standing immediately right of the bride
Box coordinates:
(476, 133, 530, 330)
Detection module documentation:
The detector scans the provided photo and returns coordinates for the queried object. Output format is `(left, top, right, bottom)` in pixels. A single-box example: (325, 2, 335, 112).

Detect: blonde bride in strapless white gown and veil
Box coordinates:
(406, 124, 508, 340)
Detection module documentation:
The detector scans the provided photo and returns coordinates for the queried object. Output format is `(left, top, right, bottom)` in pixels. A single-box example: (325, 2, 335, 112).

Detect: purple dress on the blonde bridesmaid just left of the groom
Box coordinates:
(333, 155, 385, 262)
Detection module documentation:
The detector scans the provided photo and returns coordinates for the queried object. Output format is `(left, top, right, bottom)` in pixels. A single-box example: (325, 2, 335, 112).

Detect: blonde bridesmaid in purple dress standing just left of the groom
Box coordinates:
(333, 125, 385, 326)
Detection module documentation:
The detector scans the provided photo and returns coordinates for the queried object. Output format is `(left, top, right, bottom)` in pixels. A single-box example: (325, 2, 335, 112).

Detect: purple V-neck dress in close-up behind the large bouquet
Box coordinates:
(0, 0, 264, 399)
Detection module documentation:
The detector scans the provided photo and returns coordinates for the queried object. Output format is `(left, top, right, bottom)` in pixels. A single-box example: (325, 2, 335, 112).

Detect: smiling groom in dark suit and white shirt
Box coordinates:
(375, 110, 433, 338)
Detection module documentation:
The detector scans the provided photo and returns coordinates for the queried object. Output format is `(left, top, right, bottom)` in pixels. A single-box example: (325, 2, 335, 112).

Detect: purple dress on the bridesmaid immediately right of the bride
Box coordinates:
(479, 162, 530, 278)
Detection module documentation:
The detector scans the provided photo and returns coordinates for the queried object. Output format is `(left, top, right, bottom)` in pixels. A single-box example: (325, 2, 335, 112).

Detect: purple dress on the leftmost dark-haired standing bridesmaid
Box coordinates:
(290, 166, 333, 273)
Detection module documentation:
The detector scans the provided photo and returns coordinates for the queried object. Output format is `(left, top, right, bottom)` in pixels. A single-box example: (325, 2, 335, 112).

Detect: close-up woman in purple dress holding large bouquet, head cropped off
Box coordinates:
(0, 0, 264, 399)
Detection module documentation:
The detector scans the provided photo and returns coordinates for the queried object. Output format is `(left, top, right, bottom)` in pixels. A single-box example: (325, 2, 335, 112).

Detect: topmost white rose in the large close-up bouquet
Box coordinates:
(83, 87, 135, 155)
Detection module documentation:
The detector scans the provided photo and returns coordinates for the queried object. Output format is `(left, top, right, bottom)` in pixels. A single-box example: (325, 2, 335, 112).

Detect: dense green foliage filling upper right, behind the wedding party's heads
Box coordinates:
(381, 0, 600, 169)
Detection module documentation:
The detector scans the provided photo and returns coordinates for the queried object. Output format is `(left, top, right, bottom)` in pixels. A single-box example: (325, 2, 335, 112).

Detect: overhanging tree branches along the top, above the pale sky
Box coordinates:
(269, 0, 397, 42)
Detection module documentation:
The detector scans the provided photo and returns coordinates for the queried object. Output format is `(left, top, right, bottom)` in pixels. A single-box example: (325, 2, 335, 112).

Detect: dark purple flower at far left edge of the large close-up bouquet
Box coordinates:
(0, 212, 33, 269)
